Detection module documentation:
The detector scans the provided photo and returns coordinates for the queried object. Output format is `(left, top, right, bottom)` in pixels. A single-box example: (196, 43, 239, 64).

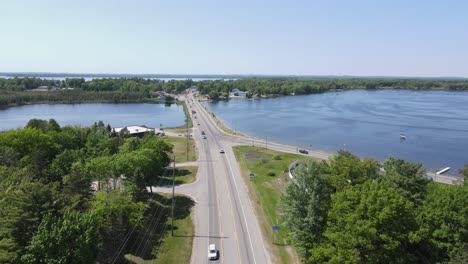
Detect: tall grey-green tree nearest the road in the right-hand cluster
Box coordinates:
(280, 161, 331, 262)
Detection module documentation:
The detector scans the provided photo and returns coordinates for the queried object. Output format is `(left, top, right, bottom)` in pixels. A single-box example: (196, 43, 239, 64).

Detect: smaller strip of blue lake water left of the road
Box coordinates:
(0, 104, 185, 130)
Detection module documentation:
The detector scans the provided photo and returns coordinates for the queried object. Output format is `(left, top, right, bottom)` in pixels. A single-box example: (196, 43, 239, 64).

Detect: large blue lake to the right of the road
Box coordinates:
(206, 90, 468, 174)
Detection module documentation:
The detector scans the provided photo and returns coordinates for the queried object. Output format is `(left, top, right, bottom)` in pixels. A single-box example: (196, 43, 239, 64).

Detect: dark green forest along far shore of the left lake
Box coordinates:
(0, 78, 193, 107)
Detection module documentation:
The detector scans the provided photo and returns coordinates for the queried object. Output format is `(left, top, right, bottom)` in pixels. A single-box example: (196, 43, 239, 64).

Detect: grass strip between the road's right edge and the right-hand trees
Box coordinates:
(233, 146, 311, 263)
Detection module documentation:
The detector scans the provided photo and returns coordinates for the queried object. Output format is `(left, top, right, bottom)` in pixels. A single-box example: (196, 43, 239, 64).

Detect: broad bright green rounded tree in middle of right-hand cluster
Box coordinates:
(310, 181, 417, 263)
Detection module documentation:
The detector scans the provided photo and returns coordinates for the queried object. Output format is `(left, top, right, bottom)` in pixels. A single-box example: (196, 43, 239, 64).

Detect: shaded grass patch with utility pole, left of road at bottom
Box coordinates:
(125, 194, 195, 264)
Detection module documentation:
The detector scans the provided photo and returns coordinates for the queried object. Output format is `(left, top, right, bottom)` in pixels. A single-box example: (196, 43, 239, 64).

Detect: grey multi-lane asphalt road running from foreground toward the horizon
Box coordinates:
(155, 94, 272, 264)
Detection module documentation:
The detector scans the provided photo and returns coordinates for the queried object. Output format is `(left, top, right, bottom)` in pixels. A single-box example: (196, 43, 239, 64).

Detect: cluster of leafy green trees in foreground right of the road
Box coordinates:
(280, 151, 468, 264)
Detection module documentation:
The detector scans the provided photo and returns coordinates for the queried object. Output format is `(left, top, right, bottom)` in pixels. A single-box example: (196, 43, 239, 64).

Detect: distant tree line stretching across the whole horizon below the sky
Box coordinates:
(0, 77, 468, 107)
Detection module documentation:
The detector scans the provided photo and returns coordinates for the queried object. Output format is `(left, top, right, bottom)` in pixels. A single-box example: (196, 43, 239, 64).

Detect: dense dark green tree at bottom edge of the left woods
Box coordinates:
(21, 211, 98, 264)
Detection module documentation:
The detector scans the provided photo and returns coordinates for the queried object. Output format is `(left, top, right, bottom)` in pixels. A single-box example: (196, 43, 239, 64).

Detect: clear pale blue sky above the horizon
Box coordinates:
(0, 0, 468, 77)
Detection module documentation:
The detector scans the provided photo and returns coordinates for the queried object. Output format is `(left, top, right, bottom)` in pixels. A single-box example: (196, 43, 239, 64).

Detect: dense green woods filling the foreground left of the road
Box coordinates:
(0, 119, 181, 264)
